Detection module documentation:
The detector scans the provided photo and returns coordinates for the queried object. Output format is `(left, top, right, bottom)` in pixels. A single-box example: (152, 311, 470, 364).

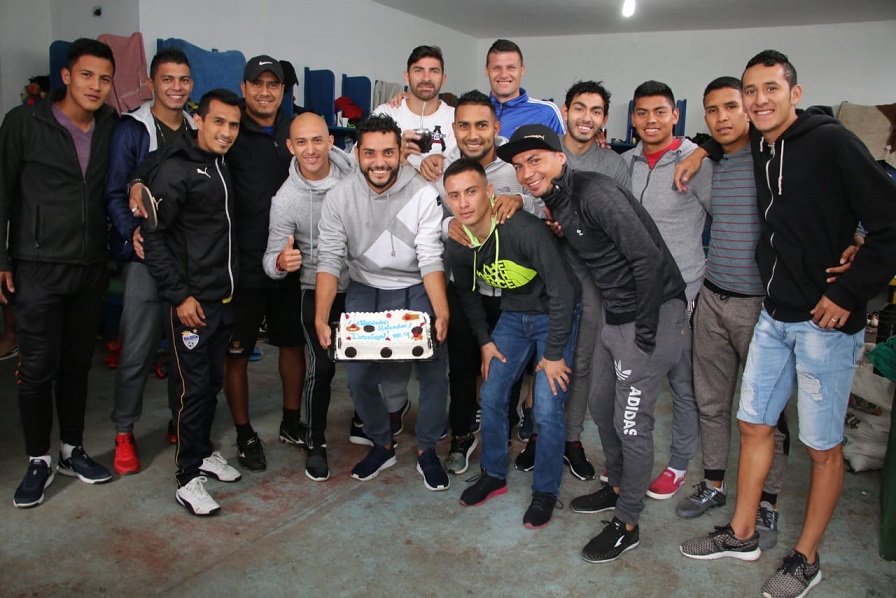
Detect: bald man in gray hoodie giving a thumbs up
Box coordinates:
(264, 112, 357, 482)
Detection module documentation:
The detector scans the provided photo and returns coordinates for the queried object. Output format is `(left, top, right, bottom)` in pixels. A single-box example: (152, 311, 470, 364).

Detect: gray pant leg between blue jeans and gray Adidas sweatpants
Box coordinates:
(566, 278, 604, 442)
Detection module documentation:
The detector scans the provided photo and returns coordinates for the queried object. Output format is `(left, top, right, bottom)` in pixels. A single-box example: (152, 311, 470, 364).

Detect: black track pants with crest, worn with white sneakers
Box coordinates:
(165, 302, 233, 487)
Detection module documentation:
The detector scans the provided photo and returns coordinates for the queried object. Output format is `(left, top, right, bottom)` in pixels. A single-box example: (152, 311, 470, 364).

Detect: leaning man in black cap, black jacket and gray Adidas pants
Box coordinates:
(498, 125, 687, 563)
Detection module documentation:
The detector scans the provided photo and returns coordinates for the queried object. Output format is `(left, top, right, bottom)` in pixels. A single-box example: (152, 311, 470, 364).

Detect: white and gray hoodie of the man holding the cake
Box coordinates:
(317, 166, 444, 290)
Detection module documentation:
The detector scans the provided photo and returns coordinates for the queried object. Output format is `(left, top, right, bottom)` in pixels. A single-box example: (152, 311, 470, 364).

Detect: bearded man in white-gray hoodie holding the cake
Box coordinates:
(315, 115, 449, 491)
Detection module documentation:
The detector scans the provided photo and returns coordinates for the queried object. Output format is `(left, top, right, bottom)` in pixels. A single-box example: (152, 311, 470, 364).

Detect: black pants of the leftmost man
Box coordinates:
(11, 261, 109, 457)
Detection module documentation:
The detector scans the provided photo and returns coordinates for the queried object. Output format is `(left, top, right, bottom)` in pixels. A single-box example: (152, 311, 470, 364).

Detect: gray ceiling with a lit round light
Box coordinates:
(373, 0, 896, 39)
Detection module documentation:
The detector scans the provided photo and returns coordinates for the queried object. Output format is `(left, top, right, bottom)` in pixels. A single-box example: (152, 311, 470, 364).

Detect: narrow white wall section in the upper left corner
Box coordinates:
(0, 0, 52, 114)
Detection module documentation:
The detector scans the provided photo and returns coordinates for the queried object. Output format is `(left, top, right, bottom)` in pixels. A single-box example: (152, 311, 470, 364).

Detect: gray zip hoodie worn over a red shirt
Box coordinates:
(622, 139, 712, 301)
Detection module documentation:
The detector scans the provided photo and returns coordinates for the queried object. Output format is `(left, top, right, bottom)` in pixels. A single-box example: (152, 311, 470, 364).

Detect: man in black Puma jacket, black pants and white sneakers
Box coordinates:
(143, 89, 240, 515)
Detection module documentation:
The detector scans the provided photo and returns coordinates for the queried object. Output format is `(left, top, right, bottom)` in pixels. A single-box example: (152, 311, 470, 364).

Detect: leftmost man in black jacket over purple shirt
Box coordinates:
(0, 39, 117, 507)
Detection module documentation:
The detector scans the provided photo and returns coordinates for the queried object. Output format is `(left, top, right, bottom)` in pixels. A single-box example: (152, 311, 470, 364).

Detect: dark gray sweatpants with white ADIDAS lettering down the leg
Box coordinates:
(589, 299, 688, 525)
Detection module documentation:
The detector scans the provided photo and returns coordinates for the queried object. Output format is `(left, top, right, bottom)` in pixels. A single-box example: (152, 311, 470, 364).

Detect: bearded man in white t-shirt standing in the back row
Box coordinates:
(373, 46, 457, 181)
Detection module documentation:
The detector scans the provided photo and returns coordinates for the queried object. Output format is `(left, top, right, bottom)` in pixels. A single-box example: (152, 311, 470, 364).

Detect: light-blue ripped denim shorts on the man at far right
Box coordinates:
(737, 308, 863, 451)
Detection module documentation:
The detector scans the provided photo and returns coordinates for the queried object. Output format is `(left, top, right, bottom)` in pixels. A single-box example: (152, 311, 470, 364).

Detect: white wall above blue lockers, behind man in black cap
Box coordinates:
(140, 0, 477, 104)
